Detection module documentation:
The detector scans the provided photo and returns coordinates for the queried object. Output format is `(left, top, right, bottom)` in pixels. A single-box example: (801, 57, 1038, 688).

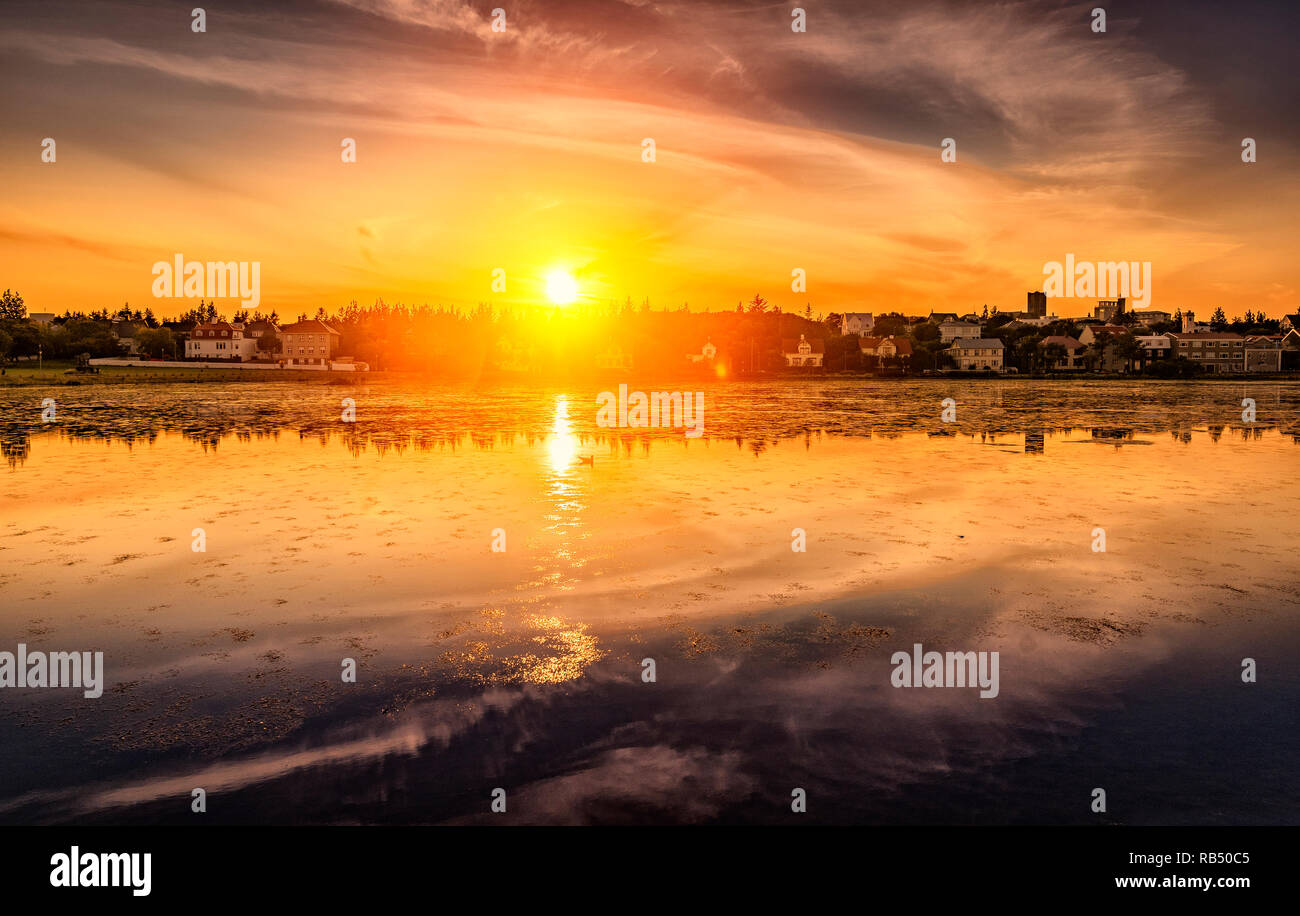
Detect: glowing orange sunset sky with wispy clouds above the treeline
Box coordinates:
(0, 0, 1300, 317)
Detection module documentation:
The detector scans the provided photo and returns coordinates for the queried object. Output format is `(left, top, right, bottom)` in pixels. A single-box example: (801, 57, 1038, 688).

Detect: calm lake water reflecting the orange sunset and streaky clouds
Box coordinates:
(0, 379, 1300, 824)
